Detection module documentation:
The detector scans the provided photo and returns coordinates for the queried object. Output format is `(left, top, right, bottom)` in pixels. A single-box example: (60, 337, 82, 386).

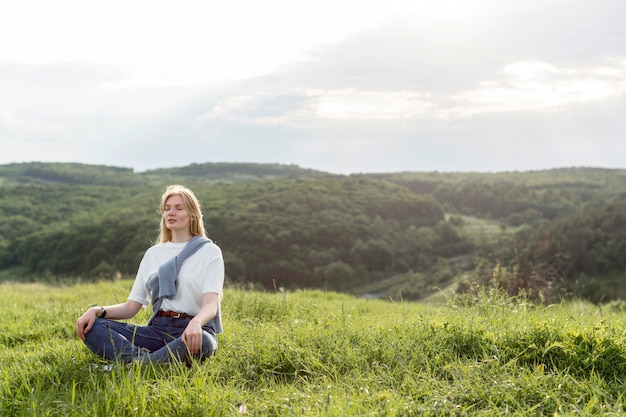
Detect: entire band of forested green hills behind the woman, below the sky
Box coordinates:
(0, 163, 626, 303)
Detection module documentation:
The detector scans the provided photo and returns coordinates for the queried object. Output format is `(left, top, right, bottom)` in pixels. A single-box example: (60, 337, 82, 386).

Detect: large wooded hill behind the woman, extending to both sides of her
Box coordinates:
(0, 171, 447, 290)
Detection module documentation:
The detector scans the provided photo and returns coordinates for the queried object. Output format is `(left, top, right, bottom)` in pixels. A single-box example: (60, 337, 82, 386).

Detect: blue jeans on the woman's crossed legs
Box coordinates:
(85, 317, 218, 363)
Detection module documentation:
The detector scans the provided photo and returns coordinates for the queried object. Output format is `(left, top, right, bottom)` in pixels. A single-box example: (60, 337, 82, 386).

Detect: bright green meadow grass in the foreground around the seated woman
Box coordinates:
(0, 281, 626, 416)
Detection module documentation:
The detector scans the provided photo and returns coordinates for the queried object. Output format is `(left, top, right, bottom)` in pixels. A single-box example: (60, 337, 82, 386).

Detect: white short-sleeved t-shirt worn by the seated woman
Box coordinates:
(128, 237, 224, 316)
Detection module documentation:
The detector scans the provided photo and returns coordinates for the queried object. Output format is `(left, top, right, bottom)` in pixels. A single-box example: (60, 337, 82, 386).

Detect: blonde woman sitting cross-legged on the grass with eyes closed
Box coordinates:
(76, 185, 224, 363)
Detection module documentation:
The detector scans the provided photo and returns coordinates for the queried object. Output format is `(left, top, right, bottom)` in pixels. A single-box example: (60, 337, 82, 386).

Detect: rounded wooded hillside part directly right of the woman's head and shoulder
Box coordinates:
(207, 178, 443, 289)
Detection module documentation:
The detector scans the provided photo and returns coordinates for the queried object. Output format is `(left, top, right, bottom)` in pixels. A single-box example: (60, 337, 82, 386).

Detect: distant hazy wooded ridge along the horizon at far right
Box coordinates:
(363, 168, 626, 222)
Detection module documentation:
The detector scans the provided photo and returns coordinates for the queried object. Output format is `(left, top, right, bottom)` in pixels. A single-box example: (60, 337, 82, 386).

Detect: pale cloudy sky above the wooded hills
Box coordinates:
(0, 0, 626, 174)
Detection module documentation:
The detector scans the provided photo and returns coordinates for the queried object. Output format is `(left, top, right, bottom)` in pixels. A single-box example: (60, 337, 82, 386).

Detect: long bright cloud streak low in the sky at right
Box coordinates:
(205, 60, 626, 127)
